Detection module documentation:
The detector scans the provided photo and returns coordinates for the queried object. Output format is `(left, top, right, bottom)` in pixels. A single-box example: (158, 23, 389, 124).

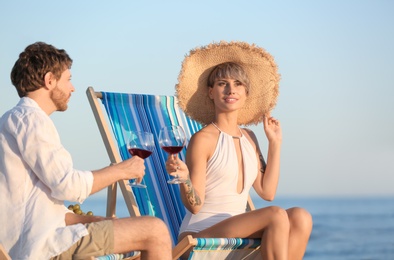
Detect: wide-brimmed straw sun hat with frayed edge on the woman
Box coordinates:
(176, 41, 280, 125)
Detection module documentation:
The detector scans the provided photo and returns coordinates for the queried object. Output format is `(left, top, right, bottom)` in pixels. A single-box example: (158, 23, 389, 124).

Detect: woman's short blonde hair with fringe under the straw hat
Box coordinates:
(208, 62, 249, 93)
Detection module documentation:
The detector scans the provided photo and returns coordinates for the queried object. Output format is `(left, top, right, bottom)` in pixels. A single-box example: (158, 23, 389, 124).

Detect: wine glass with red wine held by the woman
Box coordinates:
(159, 125, 186, 184)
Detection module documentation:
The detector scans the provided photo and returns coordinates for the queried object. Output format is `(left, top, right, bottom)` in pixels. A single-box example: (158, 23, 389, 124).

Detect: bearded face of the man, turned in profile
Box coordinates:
(50, 69, 75, 111)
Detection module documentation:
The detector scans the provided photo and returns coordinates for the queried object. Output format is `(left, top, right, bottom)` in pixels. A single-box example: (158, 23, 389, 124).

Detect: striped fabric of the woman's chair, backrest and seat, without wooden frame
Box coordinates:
(88, 89, 261, 259)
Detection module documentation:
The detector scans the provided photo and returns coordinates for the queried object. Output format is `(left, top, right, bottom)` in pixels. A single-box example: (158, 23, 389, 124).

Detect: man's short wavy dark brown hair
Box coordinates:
(11, 42, 72, 97)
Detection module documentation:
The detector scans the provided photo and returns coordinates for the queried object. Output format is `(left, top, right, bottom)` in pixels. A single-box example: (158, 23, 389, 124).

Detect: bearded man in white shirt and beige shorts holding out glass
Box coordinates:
(0, 42, 171, 259)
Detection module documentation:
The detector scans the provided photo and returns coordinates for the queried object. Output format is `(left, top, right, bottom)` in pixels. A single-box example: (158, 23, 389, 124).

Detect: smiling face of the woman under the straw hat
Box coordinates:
(208, 78, 247, 112)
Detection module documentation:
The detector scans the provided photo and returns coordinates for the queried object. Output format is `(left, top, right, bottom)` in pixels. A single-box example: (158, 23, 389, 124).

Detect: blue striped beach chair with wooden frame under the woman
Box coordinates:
(86, 87, 261, 259)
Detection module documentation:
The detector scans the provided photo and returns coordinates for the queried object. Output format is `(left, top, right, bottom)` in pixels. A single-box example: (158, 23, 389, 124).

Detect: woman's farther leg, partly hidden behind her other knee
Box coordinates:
(287, 208, 313, 260)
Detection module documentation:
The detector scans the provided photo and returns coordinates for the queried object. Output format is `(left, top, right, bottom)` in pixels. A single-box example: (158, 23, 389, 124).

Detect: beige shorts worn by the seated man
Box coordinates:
(51, 220, 114, 260)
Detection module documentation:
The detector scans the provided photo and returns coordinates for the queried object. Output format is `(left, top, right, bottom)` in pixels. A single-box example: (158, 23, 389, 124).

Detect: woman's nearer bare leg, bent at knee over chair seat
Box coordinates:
(194, 206, 290, 260)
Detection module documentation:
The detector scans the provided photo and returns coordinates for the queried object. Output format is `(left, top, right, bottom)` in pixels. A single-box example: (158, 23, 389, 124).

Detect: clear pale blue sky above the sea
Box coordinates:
(0, 0, 394, 197)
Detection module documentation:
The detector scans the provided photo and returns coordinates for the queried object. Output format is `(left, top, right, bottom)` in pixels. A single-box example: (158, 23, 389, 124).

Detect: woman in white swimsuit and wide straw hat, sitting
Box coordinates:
(166, 42, 312, 259)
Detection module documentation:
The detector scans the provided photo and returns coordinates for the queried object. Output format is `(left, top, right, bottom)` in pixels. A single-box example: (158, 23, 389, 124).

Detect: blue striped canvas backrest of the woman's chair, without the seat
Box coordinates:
(102, 92, 202, 244)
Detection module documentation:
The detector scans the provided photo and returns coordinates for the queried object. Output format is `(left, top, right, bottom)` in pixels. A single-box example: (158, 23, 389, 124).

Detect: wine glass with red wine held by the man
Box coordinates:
(127, 131, 155, 188)
